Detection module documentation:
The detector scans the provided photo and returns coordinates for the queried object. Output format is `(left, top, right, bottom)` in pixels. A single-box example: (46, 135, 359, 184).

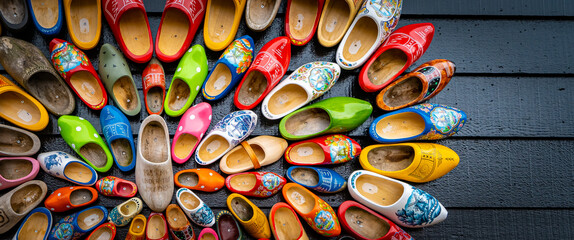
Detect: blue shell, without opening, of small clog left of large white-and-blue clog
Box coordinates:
(286, 166, 347, 193)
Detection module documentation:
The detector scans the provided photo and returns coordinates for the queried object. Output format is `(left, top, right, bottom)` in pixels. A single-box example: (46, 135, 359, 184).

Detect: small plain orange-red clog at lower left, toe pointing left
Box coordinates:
(44, 186, 98, 212)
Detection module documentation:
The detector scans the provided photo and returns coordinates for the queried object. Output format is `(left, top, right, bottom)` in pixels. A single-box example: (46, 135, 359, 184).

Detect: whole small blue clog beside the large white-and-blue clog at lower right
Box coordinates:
(286, 166, 347, 193)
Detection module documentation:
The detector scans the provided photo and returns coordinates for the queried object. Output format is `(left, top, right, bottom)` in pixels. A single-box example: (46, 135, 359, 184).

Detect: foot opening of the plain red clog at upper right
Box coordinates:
(367, 48, 407, 85)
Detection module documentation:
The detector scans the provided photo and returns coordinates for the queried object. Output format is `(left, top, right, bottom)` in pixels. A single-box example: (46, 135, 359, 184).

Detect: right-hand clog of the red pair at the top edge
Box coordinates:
(155, 0, 207, 62)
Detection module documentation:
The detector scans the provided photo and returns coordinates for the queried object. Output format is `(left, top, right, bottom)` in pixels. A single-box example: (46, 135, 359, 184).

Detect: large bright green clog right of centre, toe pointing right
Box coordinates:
(279, 97, 373, 140)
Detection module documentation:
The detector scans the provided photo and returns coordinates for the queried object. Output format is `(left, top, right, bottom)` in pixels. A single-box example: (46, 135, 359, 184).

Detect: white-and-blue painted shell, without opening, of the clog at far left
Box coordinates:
(38, 151, 98, 186)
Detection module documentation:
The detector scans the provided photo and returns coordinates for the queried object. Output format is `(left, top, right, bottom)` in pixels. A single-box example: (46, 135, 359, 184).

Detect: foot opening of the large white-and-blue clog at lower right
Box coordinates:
(356, 174, 404, 206)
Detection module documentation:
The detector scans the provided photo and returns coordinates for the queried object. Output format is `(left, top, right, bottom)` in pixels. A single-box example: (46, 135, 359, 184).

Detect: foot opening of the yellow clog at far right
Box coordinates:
(367, 146, 415, 172)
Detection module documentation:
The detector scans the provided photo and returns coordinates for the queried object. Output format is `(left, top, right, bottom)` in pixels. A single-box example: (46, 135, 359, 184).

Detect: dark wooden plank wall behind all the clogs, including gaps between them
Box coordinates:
(0, 0, 574, 239)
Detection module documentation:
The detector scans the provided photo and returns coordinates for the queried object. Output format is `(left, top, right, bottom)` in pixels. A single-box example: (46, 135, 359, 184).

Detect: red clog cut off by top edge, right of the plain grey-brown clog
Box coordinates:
(285, 0, 325, 46)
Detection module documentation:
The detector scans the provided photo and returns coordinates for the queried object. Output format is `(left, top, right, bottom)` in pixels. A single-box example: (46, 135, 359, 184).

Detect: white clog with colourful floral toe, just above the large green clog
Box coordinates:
(261, 62, 341, 119)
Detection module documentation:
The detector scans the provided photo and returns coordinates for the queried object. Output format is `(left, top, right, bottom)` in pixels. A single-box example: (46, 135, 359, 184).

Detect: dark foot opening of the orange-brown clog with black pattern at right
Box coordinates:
(383, 77, 423, 108)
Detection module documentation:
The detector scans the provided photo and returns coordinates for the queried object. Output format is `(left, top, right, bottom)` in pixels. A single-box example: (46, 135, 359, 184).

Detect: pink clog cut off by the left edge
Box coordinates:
(0, 157, 40, 190)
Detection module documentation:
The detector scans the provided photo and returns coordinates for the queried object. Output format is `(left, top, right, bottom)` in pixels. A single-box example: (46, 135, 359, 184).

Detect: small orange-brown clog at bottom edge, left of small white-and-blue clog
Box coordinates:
(165, 204, 195, 240)
